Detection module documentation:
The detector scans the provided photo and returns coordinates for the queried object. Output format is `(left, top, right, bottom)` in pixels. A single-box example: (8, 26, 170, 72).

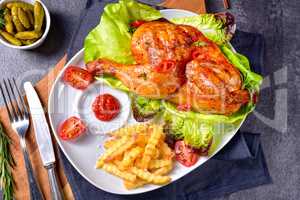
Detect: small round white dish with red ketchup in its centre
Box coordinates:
(77, 82, 131, 134)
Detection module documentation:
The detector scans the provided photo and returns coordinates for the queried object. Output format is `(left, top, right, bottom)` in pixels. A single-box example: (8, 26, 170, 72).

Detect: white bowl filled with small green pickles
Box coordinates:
(0, 0, 50, 50)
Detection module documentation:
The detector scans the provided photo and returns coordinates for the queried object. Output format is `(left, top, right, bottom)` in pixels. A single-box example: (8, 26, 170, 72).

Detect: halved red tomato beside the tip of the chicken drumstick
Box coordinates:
(63, 66, 94, 90)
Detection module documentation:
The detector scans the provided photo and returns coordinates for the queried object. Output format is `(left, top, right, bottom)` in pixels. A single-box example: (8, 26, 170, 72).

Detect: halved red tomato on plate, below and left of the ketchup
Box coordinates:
(58, 116, 86, 140)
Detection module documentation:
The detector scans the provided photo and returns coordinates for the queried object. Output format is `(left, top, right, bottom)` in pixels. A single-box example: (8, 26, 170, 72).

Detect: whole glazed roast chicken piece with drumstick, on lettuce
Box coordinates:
(87, 21, 250, 115)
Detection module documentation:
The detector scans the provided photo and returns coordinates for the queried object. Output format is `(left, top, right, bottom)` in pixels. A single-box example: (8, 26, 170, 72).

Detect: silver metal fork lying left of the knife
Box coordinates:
(0, 78, 44, 200)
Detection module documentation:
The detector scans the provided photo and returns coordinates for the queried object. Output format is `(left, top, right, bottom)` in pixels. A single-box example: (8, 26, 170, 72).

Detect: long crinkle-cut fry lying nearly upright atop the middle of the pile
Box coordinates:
(141, 126, 163, 169)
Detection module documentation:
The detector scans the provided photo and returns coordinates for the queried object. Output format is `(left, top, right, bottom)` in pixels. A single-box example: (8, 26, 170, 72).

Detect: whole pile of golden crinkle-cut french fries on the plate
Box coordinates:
(96, 124, 174, 189)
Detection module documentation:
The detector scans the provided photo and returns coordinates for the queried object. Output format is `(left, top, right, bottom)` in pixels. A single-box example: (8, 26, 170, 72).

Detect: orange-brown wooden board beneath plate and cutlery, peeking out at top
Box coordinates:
(0, 0, 206, 200)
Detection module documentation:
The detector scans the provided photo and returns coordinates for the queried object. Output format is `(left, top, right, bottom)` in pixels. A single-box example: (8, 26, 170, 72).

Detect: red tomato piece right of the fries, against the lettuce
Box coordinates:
(175, 140, 199, 167)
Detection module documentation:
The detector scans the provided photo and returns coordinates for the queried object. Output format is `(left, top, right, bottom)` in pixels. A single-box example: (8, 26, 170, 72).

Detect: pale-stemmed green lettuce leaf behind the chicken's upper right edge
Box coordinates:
(170, 14, 232, 45)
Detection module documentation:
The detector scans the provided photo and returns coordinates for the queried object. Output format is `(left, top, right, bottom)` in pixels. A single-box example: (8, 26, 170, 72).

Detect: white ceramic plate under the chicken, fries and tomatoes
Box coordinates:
(48, 9, 242, 194)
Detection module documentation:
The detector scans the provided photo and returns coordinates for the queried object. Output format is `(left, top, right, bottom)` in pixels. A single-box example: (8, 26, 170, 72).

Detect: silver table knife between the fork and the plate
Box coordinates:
(24, 82, 63, 200)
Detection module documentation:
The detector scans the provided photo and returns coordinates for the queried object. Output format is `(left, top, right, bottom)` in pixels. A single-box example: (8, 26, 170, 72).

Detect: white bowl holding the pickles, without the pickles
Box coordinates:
(0, 0, 51, 50)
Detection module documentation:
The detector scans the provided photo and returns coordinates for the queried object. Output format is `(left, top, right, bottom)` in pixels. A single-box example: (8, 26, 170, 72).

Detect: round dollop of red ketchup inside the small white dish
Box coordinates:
(92, 94, 121, 121)
